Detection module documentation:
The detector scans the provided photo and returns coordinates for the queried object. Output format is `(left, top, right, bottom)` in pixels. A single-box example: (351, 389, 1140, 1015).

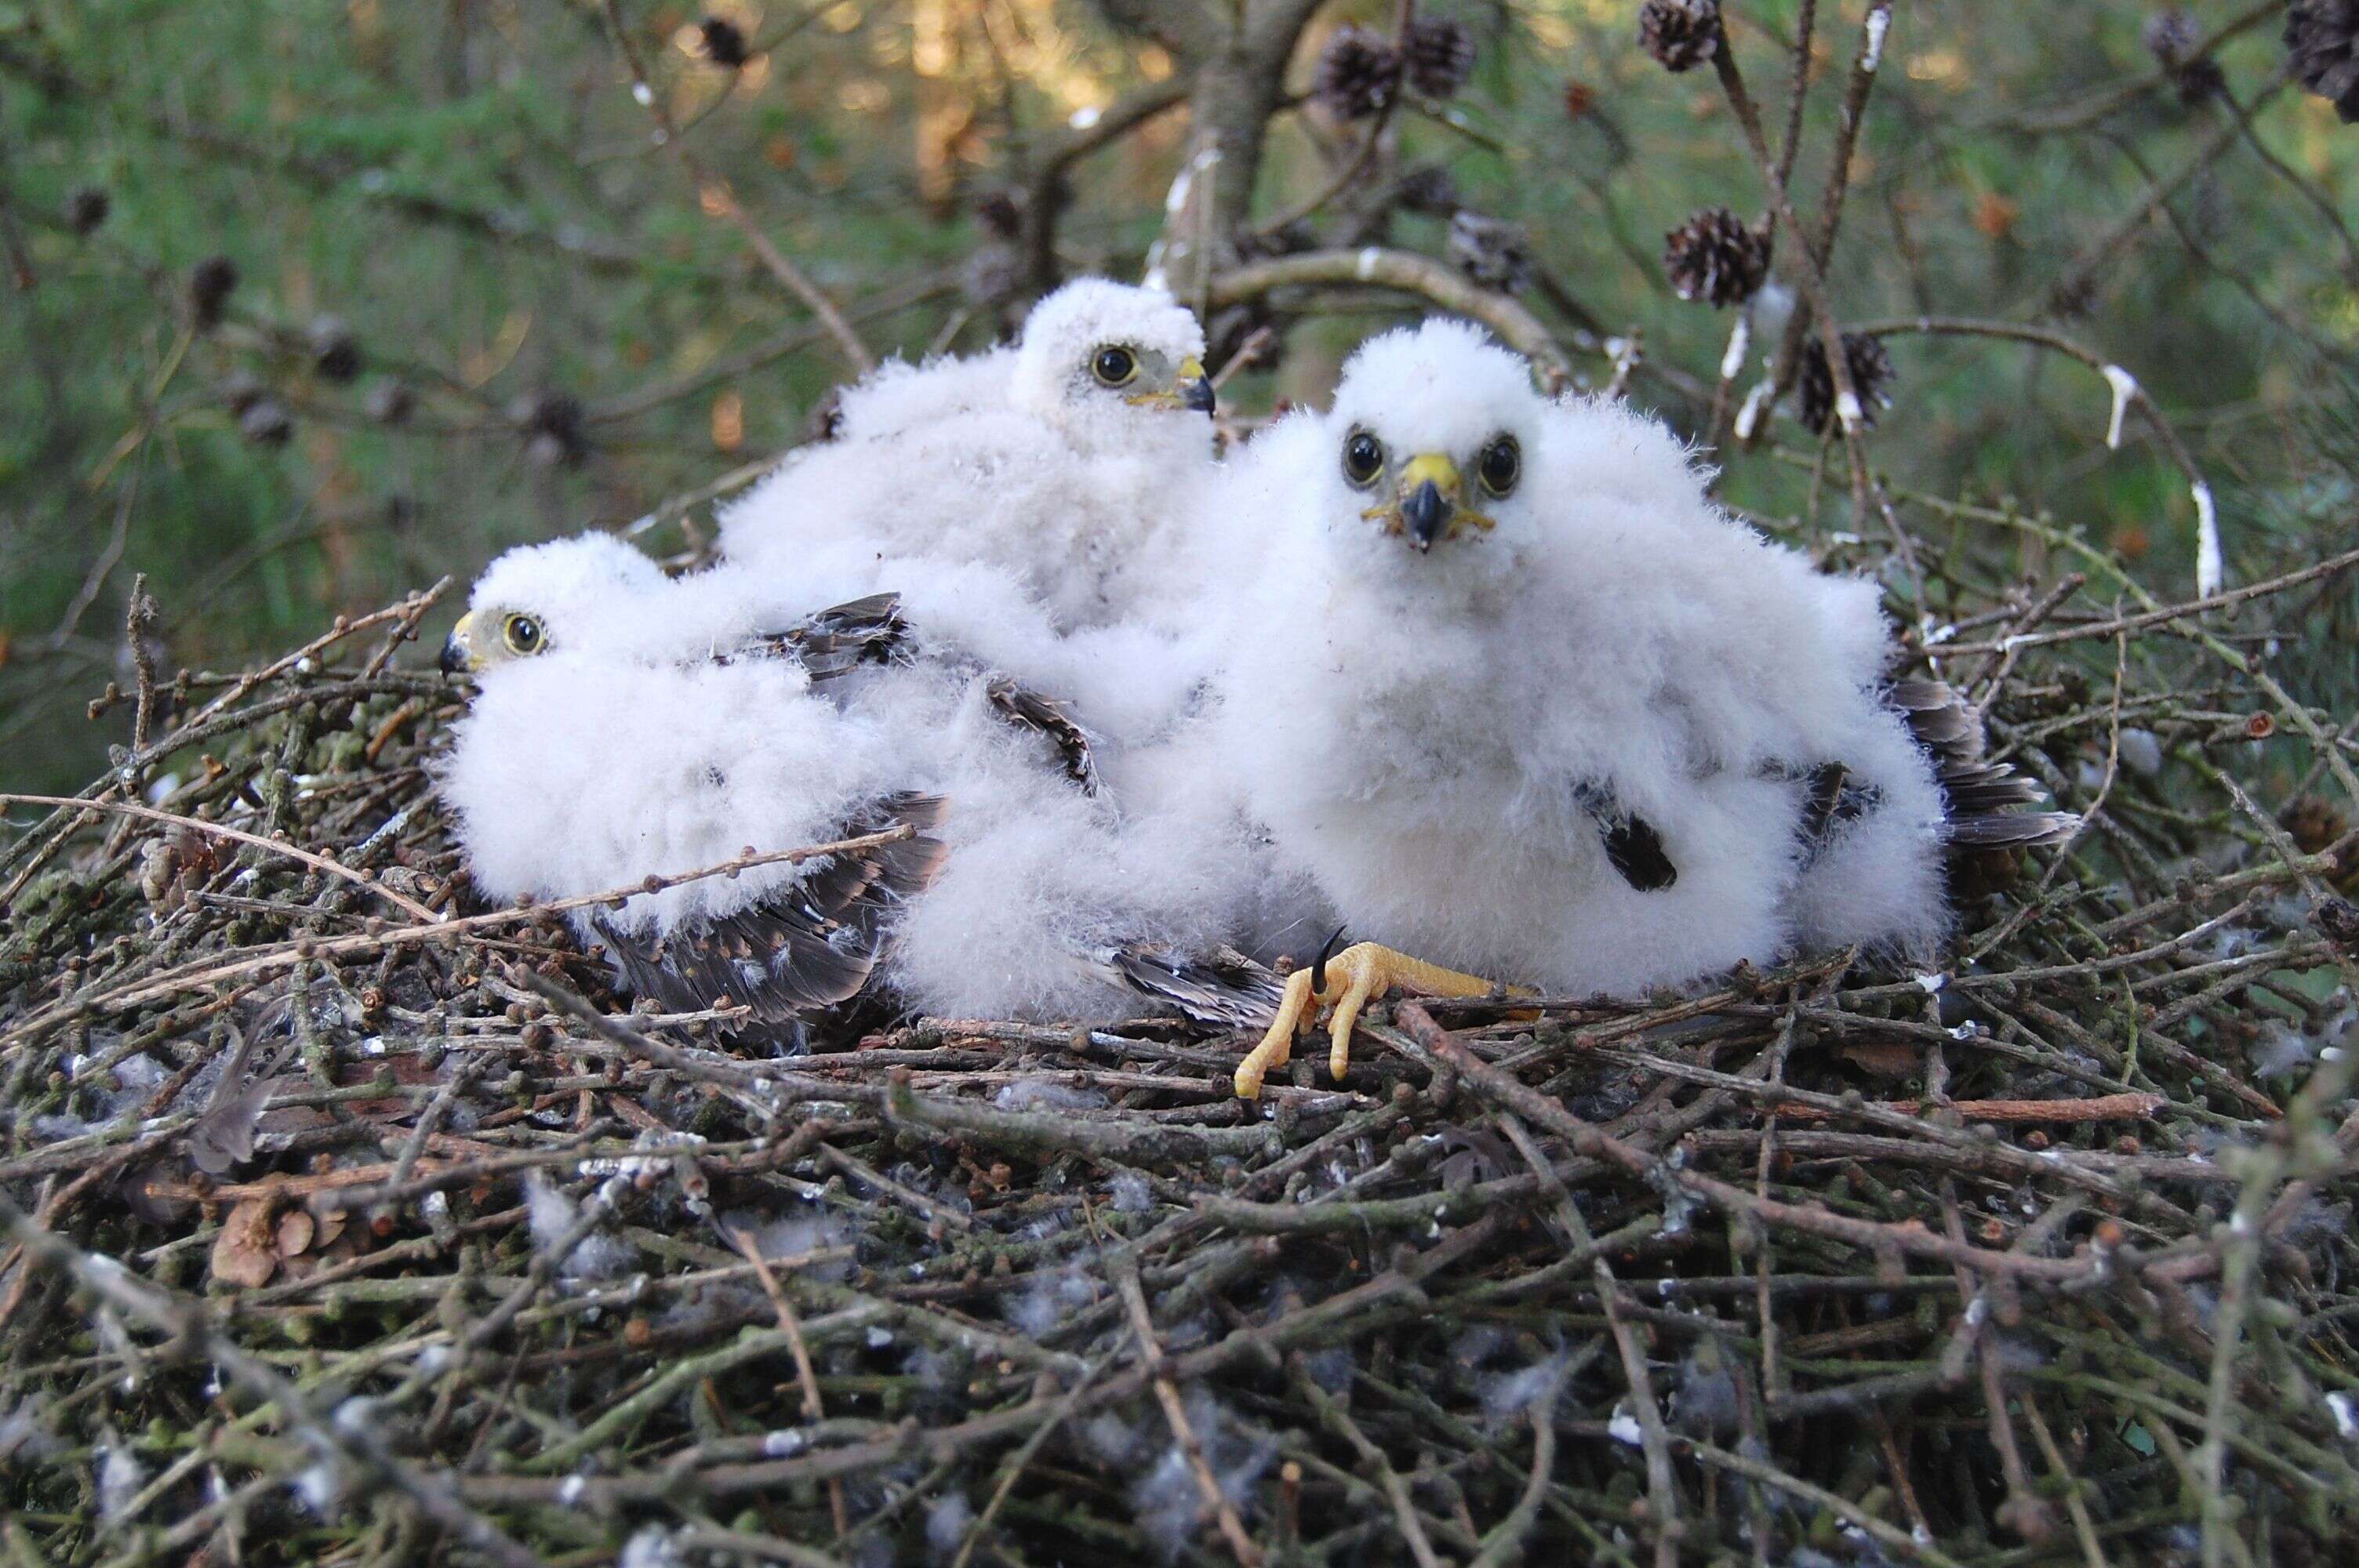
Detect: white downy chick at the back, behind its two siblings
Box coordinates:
(719, 278, 1212, 630)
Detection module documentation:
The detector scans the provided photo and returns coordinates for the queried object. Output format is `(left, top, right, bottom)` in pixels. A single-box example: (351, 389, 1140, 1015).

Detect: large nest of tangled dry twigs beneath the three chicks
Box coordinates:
(0, 528, 2359, 1568)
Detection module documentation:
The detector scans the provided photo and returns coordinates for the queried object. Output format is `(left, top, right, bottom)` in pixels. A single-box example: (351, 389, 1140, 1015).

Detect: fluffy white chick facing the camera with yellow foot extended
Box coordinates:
(1215, 321, 2056, 1087)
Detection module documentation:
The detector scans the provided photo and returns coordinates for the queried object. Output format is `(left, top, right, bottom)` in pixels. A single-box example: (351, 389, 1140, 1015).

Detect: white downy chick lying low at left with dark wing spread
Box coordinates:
(441, 538, 1255, 1023)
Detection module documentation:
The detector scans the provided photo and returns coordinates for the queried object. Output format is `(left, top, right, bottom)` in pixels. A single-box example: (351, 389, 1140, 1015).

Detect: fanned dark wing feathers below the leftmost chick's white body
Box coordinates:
(597, 795, 946, 1025)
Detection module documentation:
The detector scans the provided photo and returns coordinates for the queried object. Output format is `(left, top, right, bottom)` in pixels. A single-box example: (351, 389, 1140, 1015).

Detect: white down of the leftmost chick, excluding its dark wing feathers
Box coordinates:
(438, 535, 1245, 1016)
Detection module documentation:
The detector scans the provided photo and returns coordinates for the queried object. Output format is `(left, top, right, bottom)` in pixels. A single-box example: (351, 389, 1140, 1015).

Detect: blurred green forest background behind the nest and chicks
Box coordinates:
(0, 0, 2359, 788)
